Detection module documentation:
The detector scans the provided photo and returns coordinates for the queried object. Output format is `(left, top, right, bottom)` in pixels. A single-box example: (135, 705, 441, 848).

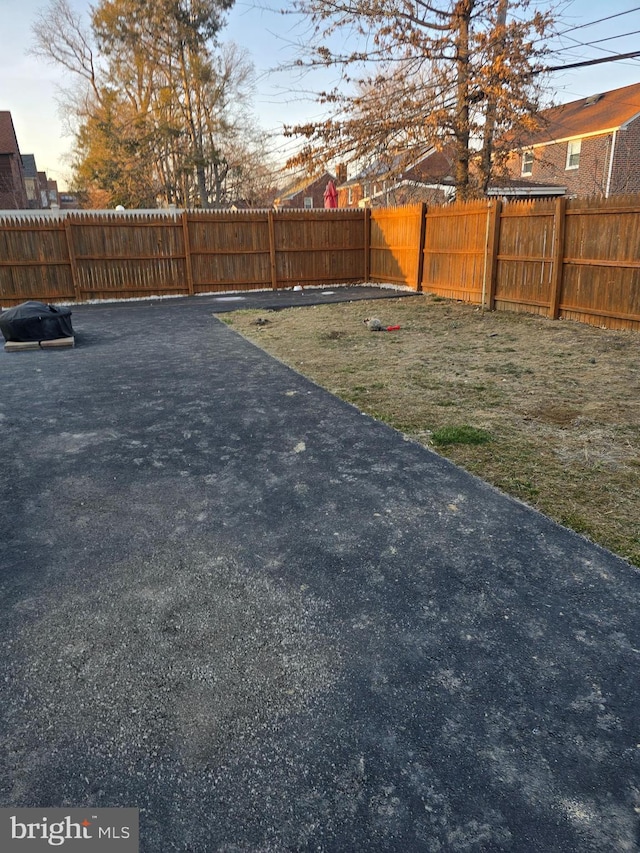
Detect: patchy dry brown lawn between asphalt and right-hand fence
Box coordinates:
(221, 294, 640, 566)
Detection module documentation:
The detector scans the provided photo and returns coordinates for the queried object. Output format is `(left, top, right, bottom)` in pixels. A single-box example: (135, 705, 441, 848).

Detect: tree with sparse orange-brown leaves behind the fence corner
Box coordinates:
(286, 0, 554, 198)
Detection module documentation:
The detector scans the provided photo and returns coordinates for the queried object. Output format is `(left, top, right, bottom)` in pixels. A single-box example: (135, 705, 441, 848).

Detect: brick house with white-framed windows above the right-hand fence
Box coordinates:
(507, 83, 640, 196)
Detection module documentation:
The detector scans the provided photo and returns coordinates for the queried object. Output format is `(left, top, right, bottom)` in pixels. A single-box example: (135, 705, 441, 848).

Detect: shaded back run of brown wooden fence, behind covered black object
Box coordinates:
(0, 210, 366, 308)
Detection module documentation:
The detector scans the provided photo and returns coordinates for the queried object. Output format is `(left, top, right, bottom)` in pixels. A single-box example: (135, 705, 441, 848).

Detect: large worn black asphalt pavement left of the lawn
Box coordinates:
(0, 290, 640, 853)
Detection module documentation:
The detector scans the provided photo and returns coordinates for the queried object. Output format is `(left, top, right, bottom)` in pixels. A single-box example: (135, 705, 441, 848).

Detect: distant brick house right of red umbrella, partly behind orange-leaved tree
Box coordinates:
(338, 149, 455, 207)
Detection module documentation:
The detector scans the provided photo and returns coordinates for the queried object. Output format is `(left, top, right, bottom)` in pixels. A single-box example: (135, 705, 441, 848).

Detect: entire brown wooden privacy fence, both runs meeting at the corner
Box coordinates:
(0, 196, 640, 330)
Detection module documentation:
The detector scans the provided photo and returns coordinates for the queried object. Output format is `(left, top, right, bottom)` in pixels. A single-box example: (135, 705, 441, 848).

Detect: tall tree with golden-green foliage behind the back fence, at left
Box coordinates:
(33, 0, 272, 208)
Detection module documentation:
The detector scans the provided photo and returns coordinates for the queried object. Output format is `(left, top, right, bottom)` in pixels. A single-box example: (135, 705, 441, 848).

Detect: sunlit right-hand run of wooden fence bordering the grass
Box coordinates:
(369, 195, 640, 330)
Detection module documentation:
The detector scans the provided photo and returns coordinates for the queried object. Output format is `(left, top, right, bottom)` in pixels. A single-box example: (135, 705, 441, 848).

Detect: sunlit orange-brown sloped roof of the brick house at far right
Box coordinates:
(519, 83, 640, 147)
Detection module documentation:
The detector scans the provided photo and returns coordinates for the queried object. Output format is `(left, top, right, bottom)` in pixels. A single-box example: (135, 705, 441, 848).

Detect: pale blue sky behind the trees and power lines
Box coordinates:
(0, 0, 640, 189)
